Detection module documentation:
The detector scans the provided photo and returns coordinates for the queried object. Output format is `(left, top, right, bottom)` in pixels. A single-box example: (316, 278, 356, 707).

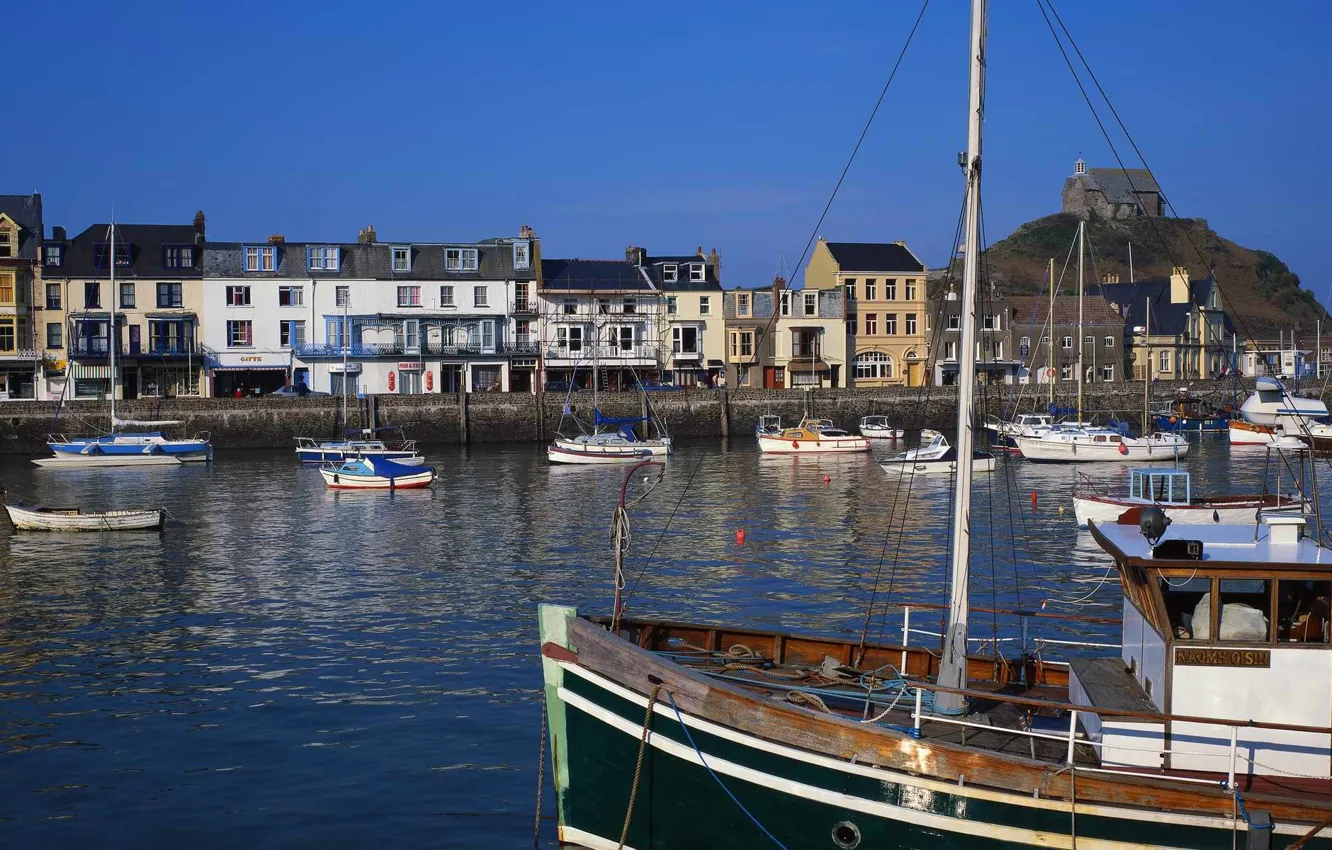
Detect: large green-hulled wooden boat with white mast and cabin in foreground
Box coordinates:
(539, 0, 1332, 850)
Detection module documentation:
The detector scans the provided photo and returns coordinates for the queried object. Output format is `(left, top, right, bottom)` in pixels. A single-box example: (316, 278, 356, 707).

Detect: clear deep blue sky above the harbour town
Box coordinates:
(0, 0, 1332, 300)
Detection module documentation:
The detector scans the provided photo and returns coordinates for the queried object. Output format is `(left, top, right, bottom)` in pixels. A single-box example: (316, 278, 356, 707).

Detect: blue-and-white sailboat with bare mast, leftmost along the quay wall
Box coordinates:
(32, 221, 213, 468)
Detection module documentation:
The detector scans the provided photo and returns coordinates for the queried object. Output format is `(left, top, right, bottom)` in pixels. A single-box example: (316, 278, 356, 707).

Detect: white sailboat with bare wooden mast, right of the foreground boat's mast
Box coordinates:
(1014, 221, 1189, 464)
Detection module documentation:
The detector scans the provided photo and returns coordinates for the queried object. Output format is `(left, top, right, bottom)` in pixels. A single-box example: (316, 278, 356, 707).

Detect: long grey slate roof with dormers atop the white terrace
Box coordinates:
(204, 238, 537, 281)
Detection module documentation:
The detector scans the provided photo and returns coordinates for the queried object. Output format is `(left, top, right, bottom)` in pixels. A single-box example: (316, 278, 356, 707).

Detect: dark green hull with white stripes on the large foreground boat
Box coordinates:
(541, 606, 1332, 850)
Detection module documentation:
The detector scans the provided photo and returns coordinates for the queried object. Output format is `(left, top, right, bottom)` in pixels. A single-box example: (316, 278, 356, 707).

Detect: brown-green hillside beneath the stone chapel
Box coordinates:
(986, 213, 1327, 337)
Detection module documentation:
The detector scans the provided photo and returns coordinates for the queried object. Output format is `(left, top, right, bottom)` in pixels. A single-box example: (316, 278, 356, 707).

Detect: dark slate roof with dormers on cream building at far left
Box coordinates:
(50, 224, 202, 280)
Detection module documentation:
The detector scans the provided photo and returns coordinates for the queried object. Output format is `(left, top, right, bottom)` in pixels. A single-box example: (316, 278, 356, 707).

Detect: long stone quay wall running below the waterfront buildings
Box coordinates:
(0, 381, 1289, 454)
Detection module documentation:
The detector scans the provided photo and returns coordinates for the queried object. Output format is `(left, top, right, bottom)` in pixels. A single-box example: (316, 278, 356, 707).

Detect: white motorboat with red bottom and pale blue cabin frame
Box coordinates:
(1074, 466, 1312, 528)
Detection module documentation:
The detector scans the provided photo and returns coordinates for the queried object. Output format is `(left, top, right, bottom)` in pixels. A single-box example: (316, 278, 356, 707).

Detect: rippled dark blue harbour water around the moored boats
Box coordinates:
(0, 440, 1316, 847)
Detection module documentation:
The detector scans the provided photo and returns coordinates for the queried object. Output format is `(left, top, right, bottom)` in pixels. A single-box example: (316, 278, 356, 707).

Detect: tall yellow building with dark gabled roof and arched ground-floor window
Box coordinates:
(805, 238, 928, 386)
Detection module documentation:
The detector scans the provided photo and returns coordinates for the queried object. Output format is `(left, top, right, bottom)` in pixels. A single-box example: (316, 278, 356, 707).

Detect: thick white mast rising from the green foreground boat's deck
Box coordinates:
(935, 0, 987, 714)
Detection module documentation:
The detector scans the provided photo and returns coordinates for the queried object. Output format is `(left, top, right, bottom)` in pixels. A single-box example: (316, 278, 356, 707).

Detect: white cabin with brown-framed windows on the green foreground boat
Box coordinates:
(1086, 516, 1332, 779)
